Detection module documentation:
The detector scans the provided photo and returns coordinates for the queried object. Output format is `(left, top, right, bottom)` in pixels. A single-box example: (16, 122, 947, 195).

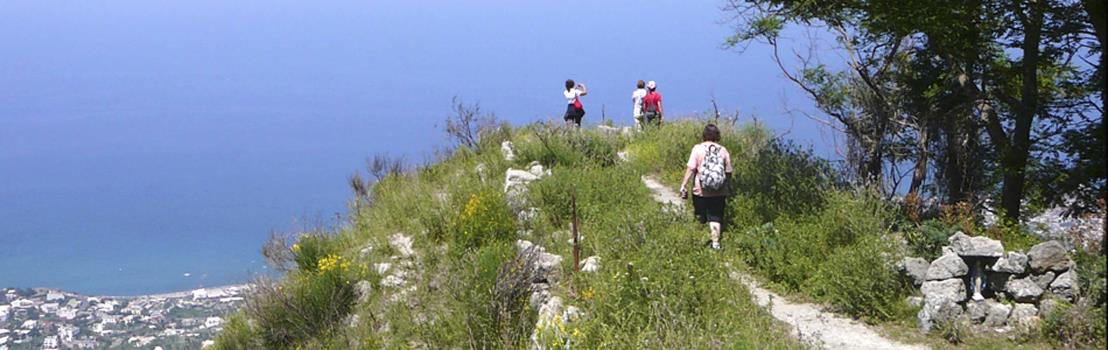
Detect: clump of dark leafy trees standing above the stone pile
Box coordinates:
(725, 0, 1104, 219)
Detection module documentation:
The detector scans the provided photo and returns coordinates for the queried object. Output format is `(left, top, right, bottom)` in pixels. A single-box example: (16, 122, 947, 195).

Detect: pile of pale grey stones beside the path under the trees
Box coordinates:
(900, 233, 1078, 332)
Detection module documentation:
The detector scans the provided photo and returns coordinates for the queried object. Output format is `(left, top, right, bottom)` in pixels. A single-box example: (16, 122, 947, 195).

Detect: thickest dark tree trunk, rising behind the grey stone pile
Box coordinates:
(1001, 1, 1043, 220)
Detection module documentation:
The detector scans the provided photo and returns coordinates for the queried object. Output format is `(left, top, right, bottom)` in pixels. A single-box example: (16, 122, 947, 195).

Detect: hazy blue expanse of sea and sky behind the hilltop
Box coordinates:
(0, 0, 830, 295)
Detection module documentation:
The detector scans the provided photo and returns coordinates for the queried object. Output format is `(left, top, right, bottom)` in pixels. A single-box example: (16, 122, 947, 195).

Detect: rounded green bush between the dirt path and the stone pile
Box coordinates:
(736, 192, 909, 321)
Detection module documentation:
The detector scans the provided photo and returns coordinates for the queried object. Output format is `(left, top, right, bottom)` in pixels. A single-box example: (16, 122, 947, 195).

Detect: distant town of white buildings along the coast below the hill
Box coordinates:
(0, 286, 248, 350)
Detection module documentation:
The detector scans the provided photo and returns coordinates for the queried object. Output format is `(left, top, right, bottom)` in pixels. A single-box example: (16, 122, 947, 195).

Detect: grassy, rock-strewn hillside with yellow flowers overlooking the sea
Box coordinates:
(216, 121, 1104, 349)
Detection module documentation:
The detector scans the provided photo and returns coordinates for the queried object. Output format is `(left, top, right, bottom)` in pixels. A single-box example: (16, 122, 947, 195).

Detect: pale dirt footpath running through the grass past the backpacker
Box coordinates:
(643, 176, 927, 349)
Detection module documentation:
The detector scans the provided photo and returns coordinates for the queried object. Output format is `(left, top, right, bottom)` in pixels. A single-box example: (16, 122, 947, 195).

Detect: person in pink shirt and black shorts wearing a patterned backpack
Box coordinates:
(681, 124, 732, 250)
